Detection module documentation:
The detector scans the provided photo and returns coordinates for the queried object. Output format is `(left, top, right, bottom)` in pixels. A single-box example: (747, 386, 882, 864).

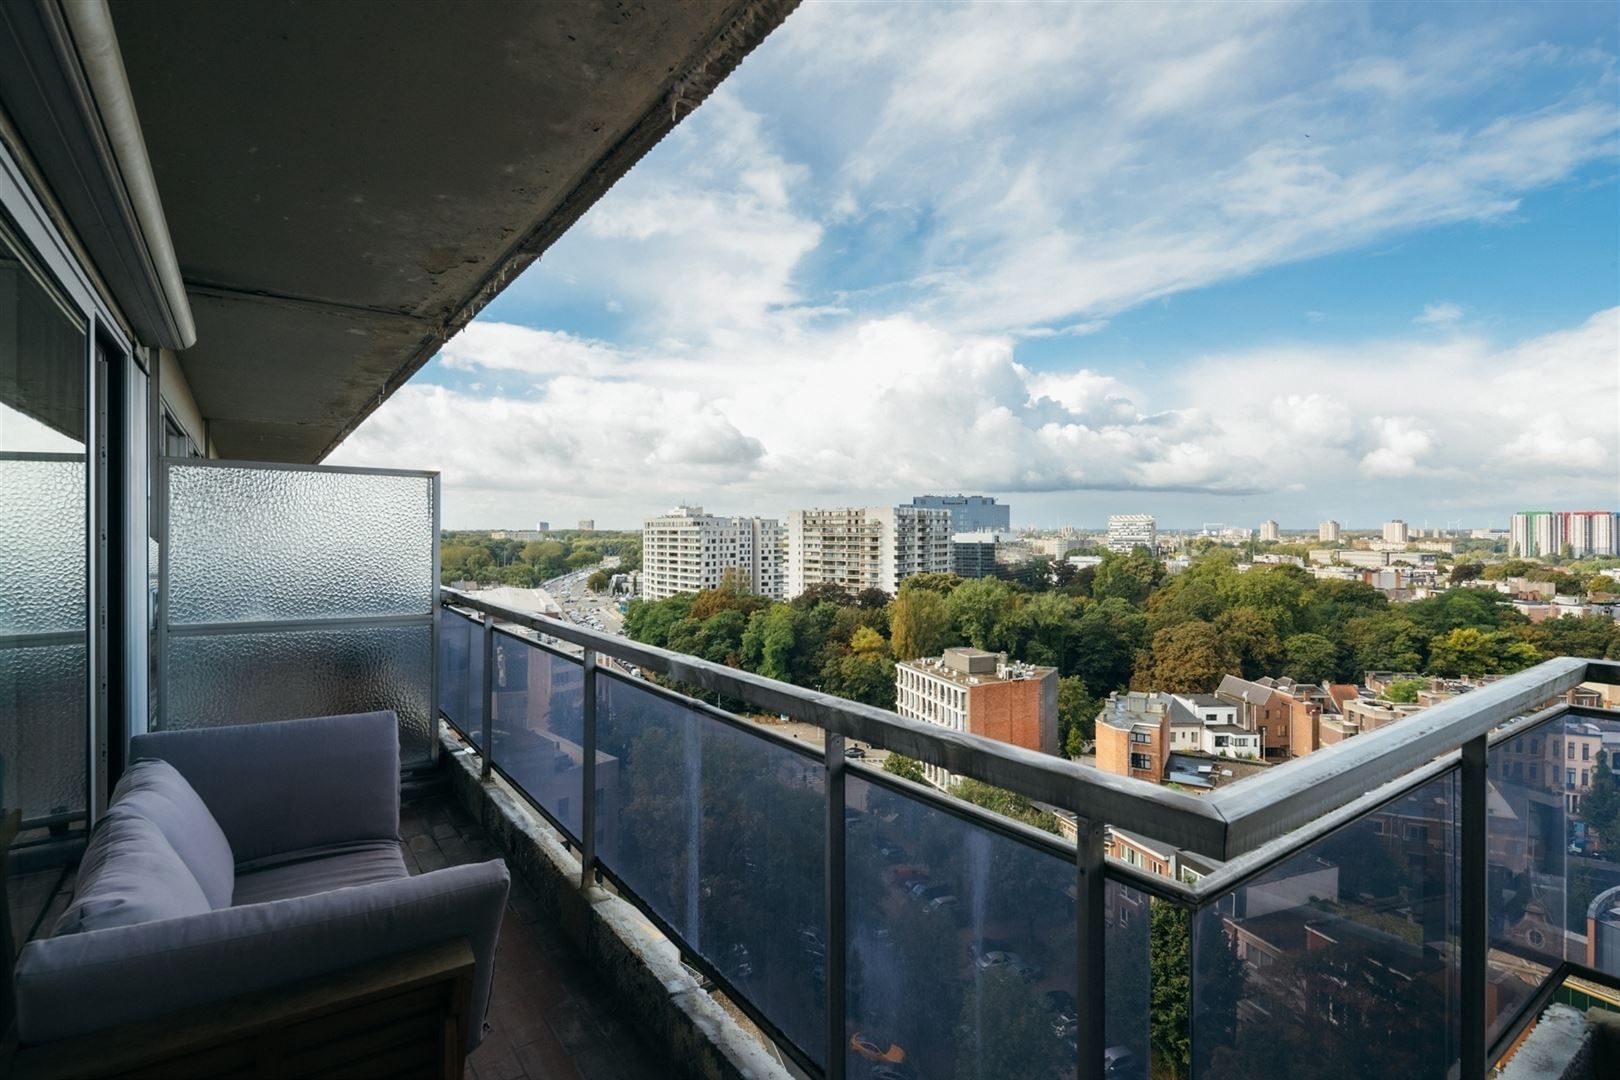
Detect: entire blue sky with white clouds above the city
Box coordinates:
(330, 0, 1620, 528)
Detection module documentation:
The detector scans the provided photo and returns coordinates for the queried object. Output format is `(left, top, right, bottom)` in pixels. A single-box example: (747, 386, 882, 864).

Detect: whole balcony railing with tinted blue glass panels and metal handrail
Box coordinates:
(437, 589, 1620, 1080)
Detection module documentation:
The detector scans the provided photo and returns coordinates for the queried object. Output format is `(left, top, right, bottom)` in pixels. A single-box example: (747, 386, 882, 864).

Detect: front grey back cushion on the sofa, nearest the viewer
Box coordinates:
(52, 808, 214, 936)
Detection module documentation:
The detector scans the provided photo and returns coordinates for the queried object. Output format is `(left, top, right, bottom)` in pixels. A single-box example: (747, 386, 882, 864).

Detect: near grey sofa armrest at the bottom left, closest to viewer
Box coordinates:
(15, 860, 510, 1049)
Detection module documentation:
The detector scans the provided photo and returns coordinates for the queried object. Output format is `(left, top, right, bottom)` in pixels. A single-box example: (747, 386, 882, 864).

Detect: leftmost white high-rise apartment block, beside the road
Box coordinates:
(642, 507, 782, 601)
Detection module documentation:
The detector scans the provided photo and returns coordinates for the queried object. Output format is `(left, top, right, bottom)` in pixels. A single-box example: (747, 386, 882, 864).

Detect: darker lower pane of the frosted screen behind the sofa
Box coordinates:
(164, 623, 433, 764)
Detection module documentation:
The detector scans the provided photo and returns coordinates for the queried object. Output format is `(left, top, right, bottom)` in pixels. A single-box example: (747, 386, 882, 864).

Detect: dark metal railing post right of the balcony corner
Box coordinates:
(1458, 735, 1490, 1080)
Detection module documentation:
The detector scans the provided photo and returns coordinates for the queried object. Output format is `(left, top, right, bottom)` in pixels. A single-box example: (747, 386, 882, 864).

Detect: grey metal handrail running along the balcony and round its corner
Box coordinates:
(441, 588, 1620, 860)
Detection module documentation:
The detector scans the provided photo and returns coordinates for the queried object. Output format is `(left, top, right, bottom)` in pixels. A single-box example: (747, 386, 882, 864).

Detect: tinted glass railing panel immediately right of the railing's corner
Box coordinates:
(1192, 771, 1460, 1080)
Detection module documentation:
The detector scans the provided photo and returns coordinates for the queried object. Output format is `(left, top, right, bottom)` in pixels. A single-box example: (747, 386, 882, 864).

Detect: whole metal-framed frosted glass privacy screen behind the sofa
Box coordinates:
(156, 458, 439, 767)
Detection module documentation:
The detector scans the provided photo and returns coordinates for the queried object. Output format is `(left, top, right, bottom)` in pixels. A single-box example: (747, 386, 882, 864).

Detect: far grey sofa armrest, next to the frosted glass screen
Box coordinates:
(130, 712, 400, 863)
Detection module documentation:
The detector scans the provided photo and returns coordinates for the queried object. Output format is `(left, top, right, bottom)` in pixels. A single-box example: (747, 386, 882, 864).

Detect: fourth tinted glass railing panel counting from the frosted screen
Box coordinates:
(844, 776, 1095, 1080)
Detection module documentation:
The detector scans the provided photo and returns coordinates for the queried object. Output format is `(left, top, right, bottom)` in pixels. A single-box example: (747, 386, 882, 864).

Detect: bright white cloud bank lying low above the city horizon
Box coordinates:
(334, 308, 1620, 523)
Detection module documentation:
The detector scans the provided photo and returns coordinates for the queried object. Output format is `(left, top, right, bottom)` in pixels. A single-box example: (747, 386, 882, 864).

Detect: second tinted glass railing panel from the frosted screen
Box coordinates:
(480, 630, 586, 840)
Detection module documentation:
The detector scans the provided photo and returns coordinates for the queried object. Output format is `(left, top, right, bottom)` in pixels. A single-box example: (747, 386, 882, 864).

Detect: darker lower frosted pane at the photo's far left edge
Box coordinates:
(0, 644, 86, 821)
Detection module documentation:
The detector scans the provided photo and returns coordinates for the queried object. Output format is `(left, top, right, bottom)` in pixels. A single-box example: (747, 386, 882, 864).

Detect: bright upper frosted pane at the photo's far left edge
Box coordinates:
(0, 452, 84, 636)
